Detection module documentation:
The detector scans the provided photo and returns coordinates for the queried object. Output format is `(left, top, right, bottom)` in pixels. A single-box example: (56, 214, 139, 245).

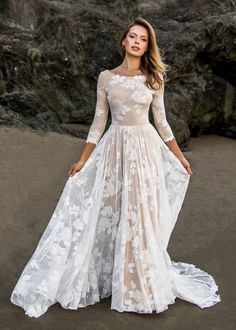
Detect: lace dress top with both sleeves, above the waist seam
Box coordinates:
(86, 70, 174, 144)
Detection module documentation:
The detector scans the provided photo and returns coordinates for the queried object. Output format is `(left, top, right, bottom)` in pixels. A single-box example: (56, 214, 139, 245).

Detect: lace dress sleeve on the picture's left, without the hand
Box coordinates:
(86, 71, 109, 144)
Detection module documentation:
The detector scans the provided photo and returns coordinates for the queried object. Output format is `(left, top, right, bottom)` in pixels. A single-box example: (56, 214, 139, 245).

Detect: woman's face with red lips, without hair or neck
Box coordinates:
(122, 25, 148, 56)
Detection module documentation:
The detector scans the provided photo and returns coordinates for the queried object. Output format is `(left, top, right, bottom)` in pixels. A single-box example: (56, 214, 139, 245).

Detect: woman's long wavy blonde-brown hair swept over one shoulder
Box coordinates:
(118, 16, 170, 90)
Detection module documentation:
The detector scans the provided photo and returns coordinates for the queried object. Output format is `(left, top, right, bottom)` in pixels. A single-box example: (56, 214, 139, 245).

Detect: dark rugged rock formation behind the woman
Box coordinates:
(0, 0, 236, 148)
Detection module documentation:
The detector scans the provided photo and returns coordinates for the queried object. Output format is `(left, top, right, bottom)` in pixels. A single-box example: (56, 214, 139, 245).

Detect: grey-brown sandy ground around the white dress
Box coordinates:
(0, 127, 236, 330)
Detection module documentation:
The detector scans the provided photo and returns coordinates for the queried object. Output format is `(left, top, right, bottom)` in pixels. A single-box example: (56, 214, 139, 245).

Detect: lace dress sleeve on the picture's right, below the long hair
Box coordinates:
(151, 80, 175, 142)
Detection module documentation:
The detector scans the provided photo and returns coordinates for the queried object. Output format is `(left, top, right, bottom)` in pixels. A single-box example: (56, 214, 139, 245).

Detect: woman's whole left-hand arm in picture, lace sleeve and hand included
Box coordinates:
(68, 72, 109, 176)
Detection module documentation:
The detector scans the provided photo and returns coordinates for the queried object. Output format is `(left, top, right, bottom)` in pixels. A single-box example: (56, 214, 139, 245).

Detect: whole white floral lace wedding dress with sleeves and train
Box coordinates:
(10, 70, 221, 317)
